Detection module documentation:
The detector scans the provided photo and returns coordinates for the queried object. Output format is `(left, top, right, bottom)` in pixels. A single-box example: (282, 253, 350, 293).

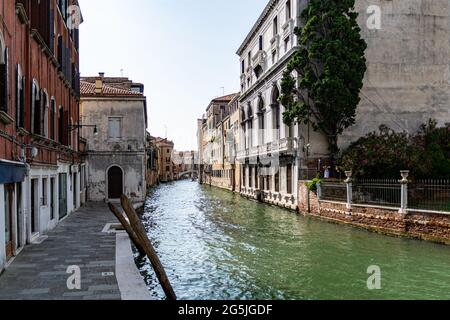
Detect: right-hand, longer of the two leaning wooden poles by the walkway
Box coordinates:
(120, 195, 177, 300)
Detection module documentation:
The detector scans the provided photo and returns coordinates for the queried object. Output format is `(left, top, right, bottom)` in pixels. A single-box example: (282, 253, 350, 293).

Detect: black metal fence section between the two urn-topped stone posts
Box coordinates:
(353, 179, 401, 207)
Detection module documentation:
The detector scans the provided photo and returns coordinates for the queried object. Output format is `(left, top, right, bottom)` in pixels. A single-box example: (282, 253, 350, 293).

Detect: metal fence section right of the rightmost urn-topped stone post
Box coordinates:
(408, 180, 450, 212)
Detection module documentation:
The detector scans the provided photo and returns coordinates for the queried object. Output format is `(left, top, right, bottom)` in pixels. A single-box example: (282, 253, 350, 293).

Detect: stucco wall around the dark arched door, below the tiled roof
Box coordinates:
(82, 98, 147, 201)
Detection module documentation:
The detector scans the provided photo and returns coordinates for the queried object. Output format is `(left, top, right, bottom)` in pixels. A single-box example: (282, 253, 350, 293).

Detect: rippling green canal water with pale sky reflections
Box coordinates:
(137, 181, 450, 300)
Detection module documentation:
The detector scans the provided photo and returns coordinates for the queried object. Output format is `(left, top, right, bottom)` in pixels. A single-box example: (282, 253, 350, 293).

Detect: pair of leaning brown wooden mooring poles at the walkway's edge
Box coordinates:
(109, 195, 177, 300)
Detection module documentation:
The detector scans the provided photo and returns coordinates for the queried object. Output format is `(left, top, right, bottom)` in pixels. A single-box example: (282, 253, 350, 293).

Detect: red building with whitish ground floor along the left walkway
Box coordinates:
(0, 0, 84, 270)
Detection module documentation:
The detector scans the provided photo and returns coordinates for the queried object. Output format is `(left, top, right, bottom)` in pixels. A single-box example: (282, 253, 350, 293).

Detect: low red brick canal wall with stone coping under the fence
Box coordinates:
(298, 181, 450, 245)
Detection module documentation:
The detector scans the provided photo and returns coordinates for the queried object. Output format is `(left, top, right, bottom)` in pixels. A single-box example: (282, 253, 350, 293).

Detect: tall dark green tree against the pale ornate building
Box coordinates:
(280, 0, 367, 167)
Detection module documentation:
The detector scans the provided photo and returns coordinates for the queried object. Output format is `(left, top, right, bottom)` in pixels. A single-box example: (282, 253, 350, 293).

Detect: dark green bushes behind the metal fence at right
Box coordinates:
(339, 120, 450, 179)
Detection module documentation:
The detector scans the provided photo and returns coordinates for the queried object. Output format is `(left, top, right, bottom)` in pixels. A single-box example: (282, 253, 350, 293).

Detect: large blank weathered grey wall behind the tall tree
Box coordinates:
(341, 0, 450, 146)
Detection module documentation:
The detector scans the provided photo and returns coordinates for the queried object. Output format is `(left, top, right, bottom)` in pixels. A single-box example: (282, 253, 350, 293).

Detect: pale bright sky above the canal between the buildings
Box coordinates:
(79, 0, 268, 151)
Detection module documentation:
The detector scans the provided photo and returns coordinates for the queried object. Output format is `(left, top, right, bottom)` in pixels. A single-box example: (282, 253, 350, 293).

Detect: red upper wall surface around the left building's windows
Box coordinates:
(0, 0, 79, 165)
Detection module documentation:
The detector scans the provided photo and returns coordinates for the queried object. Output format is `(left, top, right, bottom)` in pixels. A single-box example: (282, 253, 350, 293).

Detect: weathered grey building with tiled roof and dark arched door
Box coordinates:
(81, 74, 147, 202)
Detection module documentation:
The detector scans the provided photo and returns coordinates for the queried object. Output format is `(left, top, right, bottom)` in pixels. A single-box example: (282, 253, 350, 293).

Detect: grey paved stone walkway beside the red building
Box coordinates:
(0, 204, 121, 300)
